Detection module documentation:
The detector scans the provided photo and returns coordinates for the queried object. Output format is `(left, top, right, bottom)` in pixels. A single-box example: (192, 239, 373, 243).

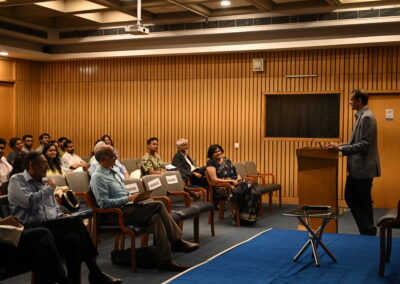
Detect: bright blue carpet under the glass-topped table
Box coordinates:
(169, 229, 400, 284)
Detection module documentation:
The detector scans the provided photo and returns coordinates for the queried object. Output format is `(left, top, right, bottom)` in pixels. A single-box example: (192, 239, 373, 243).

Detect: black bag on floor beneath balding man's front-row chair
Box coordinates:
(111, 246, 158, 269)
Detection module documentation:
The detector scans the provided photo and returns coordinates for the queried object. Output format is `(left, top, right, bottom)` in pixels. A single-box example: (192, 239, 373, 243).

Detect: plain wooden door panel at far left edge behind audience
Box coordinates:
(0, 82, 15, 154)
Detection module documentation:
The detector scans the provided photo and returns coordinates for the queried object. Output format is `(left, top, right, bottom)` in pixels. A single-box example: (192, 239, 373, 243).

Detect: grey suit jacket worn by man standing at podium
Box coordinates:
(339, 106, 381, 179)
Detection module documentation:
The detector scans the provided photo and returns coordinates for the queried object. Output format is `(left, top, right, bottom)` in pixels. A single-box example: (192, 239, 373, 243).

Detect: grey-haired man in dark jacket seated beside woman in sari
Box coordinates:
(172, 138, 207, 186)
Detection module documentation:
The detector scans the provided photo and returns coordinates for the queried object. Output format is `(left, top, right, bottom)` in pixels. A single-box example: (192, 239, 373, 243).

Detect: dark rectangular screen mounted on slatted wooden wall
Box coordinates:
(266, 94, 340, 138)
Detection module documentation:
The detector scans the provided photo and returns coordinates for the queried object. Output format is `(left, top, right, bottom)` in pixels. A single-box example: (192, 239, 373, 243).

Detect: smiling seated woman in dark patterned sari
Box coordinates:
(207, 144, 259, 222)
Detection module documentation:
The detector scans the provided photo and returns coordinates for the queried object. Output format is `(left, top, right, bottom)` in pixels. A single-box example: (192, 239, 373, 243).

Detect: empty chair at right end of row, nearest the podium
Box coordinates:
(244, 161, 282, 211)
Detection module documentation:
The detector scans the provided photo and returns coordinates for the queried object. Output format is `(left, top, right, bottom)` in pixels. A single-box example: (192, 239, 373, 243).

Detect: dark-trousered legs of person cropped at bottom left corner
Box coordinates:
(0, 216, 70, 284)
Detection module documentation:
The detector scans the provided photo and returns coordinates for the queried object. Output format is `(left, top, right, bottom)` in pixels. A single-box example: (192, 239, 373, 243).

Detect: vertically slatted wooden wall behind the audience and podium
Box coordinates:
(12, 46, 400, 202)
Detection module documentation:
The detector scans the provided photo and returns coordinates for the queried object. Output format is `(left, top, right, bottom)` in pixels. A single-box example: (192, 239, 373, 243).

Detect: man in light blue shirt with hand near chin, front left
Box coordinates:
(8, 152, 121, 284)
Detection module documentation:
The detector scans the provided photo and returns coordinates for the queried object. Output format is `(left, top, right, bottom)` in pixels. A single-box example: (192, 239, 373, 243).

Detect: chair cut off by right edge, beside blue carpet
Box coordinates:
(377, 201, 400, 276)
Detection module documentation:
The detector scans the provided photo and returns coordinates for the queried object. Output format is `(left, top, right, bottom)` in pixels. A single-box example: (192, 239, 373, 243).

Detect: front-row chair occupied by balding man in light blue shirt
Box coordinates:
(85, 190, 148, 272)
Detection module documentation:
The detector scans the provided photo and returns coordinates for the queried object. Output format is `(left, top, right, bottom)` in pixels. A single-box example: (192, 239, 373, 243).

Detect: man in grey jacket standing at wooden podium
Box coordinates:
(328, 89, 381, 235)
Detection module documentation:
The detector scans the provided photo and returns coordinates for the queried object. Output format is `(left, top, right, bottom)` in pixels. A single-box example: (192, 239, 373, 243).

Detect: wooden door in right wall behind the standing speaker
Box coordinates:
(368, 93, 400, 208)
